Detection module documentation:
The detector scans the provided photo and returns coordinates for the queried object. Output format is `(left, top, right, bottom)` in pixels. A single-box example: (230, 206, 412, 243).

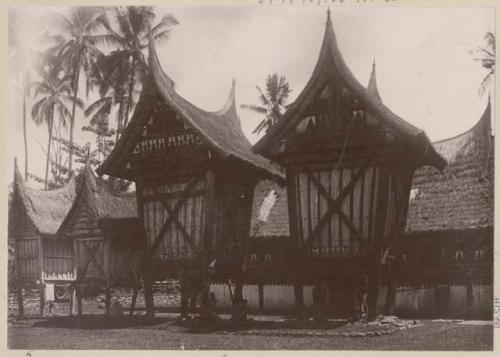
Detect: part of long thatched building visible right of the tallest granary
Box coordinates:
(395, 103, 494, 319)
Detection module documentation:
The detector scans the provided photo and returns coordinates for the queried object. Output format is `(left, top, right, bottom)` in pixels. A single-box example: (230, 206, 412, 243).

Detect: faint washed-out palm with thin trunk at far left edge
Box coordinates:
(9, 8, 30, 180)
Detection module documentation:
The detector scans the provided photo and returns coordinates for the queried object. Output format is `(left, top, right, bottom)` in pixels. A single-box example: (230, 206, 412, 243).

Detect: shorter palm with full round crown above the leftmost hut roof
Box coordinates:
(31, 56, 82, 189)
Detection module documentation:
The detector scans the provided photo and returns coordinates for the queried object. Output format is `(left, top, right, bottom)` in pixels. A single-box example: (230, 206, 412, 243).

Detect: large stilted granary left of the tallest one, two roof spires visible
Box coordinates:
(97, 35, 283, 315)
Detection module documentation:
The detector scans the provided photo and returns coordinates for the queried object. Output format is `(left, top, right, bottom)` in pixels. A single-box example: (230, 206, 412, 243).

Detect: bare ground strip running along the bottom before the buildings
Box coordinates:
(8, 313, 493, 351)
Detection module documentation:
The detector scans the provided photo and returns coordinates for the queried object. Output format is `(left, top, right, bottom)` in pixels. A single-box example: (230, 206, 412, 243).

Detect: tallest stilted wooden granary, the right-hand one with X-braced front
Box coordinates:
(254, 11, 446, 319)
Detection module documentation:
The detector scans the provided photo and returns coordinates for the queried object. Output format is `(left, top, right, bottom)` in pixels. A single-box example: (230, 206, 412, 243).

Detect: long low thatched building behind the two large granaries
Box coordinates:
(211, 60, 494, 319)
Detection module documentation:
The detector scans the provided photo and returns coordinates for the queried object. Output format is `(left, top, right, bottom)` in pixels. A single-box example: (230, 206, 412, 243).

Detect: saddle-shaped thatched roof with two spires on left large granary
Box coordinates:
(97, 34, 283, 184)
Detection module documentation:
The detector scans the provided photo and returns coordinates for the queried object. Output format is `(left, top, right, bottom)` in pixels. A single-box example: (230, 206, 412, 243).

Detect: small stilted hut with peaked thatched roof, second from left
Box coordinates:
(58, 165, 144, 314)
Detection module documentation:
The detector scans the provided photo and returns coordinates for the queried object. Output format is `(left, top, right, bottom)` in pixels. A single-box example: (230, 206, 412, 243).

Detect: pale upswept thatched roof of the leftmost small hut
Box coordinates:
(12, 162, 76, 236)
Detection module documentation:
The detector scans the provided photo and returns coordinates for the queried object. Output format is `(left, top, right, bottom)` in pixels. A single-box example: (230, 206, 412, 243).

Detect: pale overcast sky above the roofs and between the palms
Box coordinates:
(9, 6, 495, 186)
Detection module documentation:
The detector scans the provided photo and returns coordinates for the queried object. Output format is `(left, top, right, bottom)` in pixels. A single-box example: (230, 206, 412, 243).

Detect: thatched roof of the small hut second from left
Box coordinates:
(59, 165, 137, 232)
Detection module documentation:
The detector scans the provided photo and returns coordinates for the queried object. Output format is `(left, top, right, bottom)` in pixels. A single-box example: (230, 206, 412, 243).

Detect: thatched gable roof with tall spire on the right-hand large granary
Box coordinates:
(254, 10, 446, 169)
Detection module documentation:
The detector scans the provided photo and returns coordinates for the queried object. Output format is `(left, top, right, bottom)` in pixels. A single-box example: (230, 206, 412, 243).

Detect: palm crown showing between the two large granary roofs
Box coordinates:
(241, 73, 292, 134)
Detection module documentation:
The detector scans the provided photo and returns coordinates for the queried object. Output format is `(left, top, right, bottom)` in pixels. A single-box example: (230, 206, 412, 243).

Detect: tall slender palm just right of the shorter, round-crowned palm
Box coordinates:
(52, 6, 105, 177)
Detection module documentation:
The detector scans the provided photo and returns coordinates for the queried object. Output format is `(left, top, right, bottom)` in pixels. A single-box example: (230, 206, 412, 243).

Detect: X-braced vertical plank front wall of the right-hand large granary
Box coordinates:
(291, 166, 378, 256)
